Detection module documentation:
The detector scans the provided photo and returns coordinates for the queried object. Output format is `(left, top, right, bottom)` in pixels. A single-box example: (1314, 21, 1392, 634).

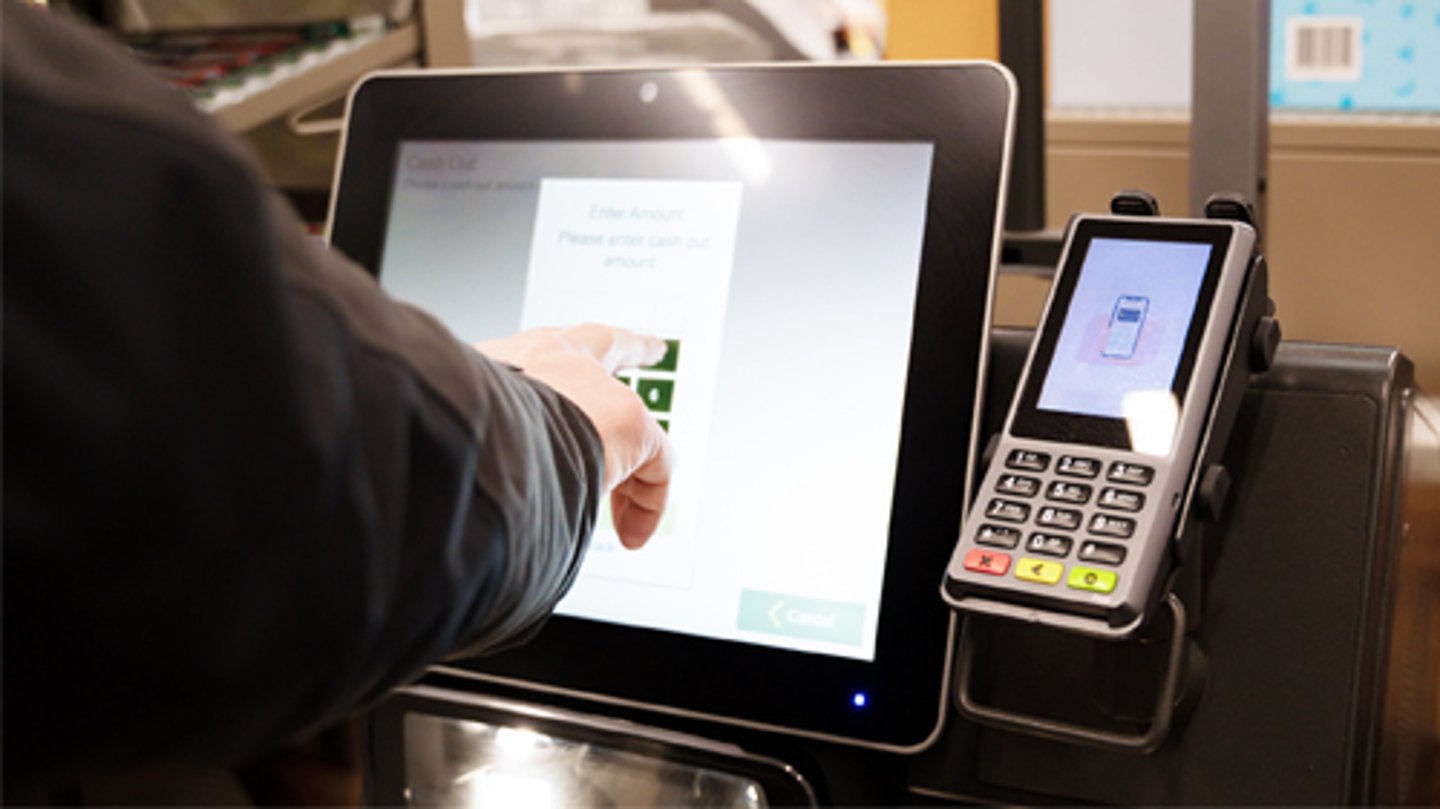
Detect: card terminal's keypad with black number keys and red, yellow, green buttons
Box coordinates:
(965, 449, 1155, 595)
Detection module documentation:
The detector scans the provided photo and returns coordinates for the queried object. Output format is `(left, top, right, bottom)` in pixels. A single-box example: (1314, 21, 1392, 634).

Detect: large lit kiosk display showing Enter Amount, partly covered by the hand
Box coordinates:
(380, 138, 933, 661)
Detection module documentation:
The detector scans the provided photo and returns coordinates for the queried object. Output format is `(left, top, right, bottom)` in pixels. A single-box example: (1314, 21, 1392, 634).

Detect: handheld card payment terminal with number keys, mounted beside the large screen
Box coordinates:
(943, 216, 1256, 639)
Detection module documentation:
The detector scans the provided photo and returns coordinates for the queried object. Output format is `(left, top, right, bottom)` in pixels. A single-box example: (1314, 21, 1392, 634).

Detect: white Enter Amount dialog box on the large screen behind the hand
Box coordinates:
(521, 178, 743, 590)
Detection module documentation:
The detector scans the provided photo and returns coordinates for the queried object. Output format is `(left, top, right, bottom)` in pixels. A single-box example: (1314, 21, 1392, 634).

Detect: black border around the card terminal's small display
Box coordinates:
(1009, 219, 1233, 451)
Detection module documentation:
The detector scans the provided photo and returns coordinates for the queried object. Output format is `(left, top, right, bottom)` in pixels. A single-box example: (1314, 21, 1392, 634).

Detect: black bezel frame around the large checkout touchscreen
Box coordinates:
(328, 62, 1014, 750)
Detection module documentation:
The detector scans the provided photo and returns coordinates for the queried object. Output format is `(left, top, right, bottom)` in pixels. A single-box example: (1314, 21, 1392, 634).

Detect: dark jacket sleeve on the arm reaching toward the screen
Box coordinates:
(0, 4, 603, 780)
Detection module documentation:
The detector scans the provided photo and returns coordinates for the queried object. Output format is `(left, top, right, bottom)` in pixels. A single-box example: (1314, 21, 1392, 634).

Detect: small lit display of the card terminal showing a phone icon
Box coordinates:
(1037, 238, 1212, 423)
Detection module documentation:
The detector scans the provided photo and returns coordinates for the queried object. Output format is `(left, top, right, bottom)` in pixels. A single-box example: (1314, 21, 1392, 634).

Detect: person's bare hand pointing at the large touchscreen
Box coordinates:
(475, 324, 674, 548)
